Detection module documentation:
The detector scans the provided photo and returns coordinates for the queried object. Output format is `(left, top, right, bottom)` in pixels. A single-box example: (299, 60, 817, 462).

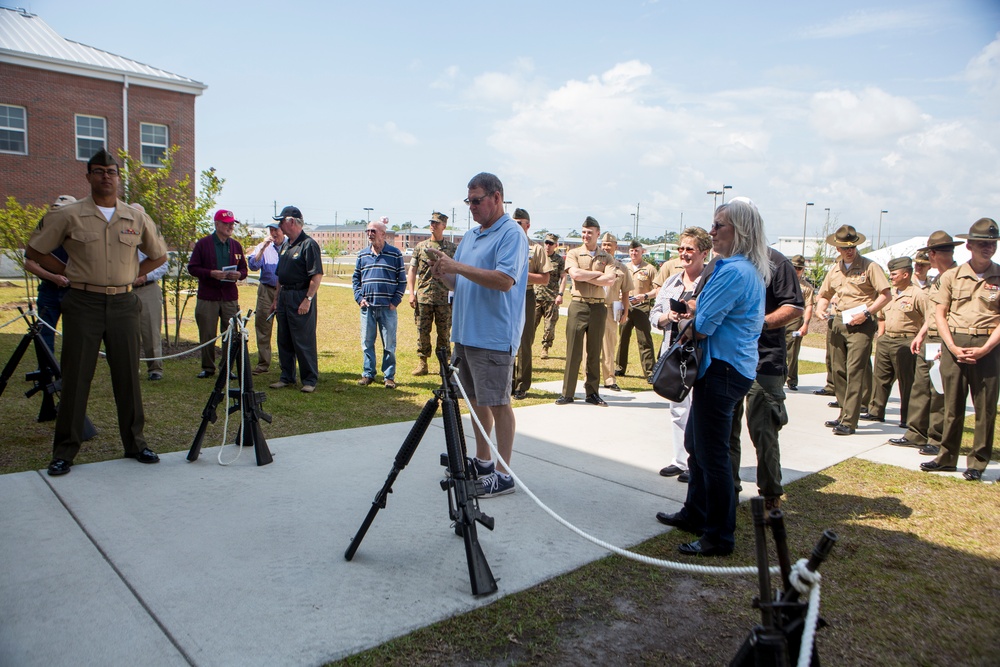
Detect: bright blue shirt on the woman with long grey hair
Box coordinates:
(694, 255, 764, 380)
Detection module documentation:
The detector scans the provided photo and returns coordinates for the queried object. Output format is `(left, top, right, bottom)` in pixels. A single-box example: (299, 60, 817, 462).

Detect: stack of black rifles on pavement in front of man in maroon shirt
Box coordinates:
(187, 310, 274, 466)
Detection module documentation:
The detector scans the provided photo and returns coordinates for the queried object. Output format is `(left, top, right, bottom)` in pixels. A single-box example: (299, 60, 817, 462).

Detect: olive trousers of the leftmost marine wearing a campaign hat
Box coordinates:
(830, 314, 878, 428)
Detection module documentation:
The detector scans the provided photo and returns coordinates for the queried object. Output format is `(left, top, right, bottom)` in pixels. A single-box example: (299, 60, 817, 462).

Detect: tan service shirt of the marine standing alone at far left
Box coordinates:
(28, 197, 167, 287)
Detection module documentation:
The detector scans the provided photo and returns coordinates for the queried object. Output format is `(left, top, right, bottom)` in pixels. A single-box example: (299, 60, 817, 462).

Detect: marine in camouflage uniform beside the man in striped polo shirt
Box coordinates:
(406, 212, 458, 376)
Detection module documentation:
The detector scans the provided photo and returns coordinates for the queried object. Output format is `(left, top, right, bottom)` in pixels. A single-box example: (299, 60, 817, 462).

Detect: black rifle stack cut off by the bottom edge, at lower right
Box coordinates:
(729, 496, 837, 667)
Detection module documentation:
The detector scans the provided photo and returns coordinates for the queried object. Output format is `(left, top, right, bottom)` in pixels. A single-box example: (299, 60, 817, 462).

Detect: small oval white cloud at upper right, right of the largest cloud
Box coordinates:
(811, 88, 926, 143)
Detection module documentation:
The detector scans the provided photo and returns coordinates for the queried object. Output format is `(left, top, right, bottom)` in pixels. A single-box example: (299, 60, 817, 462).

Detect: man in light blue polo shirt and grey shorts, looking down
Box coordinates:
(428, 173, 528, 498)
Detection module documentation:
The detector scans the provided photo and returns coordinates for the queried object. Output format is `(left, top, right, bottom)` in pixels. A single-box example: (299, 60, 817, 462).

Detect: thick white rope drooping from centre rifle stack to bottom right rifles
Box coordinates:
(449, 366, 820, 667)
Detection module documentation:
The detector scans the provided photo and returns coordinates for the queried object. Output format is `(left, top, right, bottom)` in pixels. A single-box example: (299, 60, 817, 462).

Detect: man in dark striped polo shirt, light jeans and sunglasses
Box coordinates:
(351, 218, 406, 389)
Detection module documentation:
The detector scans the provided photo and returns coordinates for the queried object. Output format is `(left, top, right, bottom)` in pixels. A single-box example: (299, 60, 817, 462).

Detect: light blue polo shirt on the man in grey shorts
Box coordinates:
(451, 213, 528, 354)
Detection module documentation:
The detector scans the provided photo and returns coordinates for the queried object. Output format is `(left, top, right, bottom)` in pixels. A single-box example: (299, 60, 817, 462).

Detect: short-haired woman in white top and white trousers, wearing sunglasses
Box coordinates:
(649, 227, 712, 483)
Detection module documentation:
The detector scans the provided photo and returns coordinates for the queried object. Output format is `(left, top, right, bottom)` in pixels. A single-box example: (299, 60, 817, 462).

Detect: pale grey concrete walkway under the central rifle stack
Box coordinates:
(0, 366, 997, 667)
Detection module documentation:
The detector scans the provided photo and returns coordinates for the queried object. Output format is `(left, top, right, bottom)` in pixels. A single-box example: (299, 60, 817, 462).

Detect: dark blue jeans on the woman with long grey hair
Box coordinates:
(681, 359, 753, 548)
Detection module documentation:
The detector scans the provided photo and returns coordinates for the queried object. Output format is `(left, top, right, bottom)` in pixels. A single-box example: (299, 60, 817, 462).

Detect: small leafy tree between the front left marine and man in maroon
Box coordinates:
(119, 145, 226, 345)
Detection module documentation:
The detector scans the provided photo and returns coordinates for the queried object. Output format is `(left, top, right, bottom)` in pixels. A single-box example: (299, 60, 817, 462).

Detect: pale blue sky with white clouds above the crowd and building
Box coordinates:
(15, 0, 1000, 242)
